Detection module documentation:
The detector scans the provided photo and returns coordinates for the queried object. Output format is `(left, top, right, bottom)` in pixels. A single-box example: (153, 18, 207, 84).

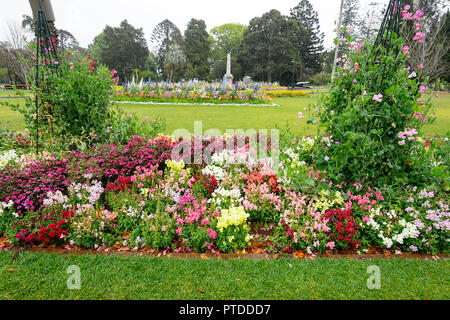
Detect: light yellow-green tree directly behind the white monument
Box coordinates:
(210, 23, 247, 78)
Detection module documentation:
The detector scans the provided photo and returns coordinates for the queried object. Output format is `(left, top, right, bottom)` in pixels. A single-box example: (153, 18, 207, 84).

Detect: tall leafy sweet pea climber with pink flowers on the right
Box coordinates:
(315, 33, 434, 185)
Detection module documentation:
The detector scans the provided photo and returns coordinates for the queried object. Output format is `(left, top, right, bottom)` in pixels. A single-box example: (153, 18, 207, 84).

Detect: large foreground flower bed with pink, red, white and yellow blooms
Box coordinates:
(0, 137, 450, 254)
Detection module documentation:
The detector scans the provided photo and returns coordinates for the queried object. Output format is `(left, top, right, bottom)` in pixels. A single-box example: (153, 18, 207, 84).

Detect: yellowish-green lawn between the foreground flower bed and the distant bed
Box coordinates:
(0, 94, 450, 135)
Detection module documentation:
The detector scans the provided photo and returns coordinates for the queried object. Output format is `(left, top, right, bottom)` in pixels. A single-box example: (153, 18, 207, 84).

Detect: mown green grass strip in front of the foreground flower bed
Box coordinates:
(0, 252, 450, 300)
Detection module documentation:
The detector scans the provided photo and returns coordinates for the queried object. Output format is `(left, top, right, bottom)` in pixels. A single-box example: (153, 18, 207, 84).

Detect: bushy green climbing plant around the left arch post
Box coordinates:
(12, 51, 113, 149)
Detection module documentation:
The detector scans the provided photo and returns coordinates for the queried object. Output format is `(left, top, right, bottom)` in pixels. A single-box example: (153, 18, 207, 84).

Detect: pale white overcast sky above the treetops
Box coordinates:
(0, 0, 389, 47)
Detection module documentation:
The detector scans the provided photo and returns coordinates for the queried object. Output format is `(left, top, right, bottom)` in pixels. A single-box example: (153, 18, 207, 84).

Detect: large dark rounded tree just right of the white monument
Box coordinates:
(240, 10, 298, 82)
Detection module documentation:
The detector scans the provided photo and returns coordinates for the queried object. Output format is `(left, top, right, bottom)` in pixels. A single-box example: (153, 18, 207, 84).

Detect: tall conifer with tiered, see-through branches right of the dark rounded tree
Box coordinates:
(290, 0, 324, 80)
